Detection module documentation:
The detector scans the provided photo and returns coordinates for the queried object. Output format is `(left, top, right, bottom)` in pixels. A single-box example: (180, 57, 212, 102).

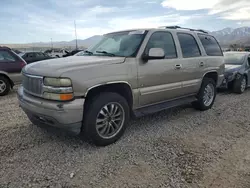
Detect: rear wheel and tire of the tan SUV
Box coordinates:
(192, 78, 216, 111)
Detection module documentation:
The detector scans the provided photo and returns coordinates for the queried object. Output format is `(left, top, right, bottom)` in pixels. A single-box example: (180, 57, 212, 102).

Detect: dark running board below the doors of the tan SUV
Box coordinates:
(134, 96, 197, 117)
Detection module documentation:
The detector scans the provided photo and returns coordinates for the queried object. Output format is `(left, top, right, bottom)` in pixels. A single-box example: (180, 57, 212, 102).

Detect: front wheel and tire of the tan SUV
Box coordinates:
(82, 92, 130, 146)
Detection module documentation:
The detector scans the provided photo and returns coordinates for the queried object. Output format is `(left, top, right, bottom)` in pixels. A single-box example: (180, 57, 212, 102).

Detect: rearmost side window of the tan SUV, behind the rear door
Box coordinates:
(198, 34, 223, 56)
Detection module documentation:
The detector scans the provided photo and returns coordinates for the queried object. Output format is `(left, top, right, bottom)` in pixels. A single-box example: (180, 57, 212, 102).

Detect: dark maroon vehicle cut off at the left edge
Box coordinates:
(0, 47, 26, 96)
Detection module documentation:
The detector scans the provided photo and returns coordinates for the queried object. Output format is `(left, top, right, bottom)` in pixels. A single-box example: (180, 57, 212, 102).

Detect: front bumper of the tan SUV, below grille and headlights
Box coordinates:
(18, 86, 85, 134)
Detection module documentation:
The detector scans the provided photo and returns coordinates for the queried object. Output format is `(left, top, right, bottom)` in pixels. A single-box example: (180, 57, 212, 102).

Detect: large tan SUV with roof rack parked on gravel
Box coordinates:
(18, 26, 225, 146)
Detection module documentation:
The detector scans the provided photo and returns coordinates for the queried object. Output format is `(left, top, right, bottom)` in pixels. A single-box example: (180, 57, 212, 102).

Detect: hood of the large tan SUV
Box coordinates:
(23, 56, 125, 77)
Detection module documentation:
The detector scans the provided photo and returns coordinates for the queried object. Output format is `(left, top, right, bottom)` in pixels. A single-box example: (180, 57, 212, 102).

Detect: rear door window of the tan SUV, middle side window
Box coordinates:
(177, 33, 201, 58)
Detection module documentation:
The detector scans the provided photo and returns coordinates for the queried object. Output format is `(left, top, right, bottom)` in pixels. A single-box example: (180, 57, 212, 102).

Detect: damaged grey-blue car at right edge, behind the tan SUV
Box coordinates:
(221, 52, 250, 94)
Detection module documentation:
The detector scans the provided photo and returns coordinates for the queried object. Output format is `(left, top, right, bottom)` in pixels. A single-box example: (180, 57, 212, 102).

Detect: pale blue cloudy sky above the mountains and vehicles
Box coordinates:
(0, 0, 250, 44)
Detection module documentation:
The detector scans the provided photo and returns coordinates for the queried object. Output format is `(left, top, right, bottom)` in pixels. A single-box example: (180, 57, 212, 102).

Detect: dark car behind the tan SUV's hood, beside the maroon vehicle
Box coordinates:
(19, 52, 52, 64)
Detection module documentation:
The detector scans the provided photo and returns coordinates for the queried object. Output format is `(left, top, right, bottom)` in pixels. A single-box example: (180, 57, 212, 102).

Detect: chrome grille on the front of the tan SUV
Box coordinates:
(22, 74, 43, 96)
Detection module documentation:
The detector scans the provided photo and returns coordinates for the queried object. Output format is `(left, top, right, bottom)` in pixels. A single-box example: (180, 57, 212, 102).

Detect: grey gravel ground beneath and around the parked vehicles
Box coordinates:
(0, 87, 250, 188)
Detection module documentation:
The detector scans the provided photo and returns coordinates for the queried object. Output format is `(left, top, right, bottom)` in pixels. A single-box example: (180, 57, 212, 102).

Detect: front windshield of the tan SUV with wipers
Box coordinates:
(77, 30, 146, 57)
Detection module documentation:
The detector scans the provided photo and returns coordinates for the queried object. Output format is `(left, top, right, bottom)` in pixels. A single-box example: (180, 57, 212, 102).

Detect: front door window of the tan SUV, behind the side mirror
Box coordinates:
(146, 31, 177, 59)
